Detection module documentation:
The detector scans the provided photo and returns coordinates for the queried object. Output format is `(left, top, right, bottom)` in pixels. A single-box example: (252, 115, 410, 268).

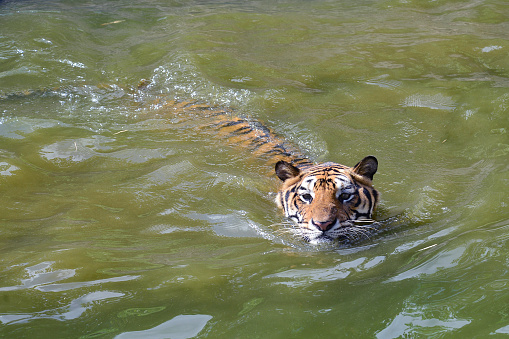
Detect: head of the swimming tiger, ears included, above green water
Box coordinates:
(275, 156, 379, 243)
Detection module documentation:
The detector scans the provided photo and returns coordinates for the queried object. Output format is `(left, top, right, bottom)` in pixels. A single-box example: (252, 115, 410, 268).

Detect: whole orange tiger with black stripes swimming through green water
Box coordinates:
(0, 81, 379, 243)
